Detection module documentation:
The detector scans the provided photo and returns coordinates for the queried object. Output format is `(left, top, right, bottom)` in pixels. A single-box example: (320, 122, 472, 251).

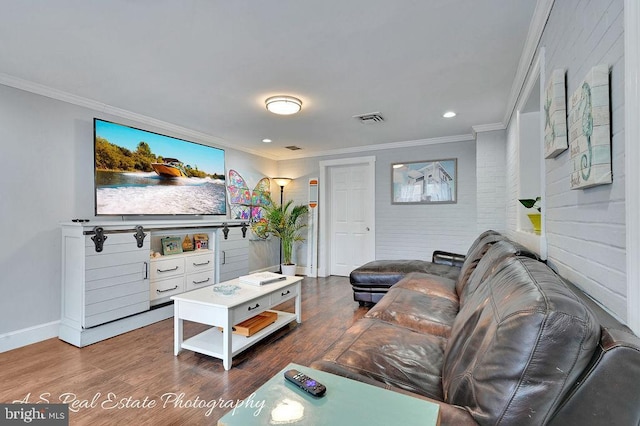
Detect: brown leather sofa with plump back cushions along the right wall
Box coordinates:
(312, 231, 640, 425)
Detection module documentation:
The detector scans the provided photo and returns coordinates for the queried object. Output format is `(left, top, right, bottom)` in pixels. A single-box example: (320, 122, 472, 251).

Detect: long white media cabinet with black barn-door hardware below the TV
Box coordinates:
(59, 220, 250, 347)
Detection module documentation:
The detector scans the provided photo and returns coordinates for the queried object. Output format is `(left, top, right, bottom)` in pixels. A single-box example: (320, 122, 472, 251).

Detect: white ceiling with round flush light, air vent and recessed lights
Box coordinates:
(0, 0, 536, 159)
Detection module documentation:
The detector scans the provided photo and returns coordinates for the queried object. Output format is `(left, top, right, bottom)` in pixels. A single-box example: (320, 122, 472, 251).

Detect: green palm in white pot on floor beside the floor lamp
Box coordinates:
(262, 198, 309, 275)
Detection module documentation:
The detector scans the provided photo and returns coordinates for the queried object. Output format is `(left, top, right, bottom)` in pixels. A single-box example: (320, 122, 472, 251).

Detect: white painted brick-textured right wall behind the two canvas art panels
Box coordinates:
(507, 0, 627, 321)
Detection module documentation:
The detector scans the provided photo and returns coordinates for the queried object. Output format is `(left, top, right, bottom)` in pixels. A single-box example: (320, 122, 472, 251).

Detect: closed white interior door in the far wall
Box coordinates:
(328, 163, 375, 276)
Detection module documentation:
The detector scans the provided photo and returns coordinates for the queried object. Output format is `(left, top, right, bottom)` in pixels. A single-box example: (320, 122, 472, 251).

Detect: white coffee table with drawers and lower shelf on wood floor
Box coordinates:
(171, 277, 302, 370)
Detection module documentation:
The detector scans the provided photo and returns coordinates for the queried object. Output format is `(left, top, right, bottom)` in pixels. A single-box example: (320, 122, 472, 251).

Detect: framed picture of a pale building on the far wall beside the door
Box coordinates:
(391, 158, 457, 204)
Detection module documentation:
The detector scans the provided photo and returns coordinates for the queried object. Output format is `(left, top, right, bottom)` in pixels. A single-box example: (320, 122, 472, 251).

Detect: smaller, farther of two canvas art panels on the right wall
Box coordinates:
(544, 69, 569, 158)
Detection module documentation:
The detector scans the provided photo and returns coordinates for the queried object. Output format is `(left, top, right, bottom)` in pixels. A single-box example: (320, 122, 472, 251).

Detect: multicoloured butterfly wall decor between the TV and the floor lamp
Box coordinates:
(227, 169, 271, 231)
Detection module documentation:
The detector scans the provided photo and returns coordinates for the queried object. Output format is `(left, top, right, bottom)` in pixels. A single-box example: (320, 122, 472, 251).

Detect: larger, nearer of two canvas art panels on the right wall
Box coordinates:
(569, 65, 612, 189)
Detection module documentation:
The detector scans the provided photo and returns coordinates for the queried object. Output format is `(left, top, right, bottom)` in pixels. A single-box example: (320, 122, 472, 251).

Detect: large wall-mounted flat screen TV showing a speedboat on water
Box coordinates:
(93, 118, 227, 216)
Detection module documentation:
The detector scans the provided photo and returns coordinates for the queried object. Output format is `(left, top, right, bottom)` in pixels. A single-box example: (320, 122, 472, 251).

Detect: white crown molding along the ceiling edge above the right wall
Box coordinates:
(502, 0, 555, 128)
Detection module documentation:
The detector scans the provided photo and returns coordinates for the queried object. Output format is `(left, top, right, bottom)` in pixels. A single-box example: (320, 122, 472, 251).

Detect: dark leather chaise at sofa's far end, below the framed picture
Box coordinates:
(349, 253, 464, 306)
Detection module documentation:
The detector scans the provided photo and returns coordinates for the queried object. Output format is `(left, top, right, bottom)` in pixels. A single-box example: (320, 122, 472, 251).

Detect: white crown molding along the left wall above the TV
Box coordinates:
(0, 73, 278, 160)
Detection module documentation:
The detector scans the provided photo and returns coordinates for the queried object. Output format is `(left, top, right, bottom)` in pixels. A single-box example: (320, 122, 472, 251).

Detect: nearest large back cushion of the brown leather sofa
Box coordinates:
(442, 257, 600, 425)
